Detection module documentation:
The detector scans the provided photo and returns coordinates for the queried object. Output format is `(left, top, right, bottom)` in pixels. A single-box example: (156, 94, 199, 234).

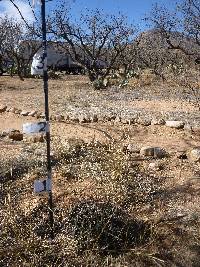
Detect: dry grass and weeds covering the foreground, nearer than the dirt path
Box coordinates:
(0, 140, 200, 267)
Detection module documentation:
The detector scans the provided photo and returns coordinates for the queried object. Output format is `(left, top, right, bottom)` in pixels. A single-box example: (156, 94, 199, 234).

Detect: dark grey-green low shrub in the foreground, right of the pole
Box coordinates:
(68, 201, 150, 255)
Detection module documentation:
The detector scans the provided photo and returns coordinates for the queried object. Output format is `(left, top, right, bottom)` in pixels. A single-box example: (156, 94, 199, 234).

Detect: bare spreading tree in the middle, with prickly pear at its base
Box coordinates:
(49, 7, 135, 86)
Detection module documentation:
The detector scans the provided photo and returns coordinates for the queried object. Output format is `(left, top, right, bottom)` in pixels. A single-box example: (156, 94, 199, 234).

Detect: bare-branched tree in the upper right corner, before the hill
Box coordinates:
(147, 0, 200, 63)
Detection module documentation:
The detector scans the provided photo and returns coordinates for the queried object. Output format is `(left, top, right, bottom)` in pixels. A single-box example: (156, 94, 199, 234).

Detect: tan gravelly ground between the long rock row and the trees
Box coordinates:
(0, 76, 200, 125)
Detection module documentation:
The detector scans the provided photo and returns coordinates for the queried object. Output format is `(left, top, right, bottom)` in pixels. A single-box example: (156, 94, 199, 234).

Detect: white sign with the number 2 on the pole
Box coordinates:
(23, 121, 49, 134)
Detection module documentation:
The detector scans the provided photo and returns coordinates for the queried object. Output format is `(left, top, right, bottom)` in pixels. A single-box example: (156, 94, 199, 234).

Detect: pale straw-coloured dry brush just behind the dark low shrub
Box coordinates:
(53, 141, 162, 208)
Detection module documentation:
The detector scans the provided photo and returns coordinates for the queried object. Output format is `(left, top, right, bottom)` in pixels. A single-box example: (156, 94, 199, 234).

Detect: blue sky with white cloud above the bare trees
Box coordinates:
(0, 0, 181, 30)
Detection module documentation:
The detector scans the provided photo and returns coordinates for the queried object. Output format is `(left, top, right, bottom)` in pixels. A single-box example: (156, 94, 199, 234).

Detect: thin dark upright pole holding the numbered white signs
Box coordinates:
(41, 0, 54, 239)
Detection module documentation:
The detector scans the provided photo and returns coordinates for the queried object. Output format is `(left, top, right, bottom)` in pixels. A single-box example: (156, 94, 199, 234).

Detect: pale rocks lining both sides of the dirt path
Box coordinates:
(0, 105, 200, 163)
